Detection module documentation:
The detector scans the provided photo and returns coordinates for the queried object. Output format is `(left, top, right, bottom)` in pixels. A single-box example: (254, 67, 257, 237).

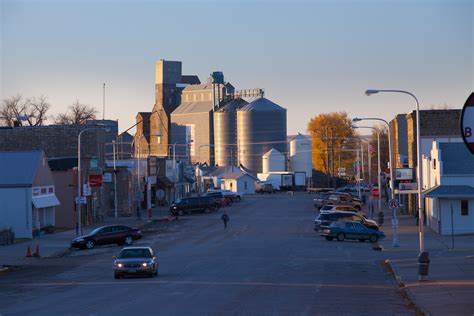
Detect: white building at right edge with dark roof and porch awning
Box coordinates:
(423, 141, 474, 235)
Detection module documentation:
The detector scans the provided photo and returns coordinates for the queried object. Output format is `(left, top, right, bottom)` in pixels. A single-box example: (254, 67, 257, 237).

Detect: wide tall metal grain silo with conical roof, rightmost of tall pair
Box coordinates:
(237, 98, 287, 174)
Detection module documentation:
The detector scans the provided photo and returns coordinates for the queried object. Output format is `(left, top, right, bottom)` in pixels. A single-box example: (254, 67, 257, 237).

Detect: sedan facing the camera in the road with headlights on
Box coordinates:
(114, 247, 158, 279)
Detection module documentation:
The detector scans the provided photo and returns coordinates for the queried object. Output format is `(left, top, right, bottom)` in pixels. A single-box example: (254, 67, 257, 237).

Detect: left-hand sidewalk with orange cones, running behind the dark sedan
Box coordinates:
(0, 207, 173, 268)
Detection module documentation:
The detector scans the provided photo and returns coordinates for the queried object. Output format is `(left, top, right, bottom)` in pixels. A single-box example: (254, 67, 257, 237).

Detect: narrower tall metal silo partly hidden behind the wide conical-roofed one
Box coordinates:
(214, 99, 248, 166)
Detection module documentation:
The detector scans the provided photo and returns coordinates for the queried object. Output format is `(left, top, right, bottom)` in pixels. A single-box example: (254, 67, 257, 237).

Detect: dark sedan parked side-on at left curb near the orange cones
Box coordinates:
(71, 225, 143, 249)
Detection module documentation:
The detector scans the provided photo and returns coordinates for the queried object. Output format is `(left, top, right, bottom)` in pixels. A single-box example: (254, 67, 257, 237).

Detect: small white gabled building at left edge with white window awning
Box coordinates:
(0, 151, 59, 238)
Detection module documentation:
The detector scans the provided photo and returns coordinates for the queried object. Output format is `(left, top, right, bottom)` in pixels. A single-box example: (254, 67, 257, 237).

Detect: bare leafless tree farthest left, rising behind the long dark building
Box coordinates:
(0, 95, 51, 126)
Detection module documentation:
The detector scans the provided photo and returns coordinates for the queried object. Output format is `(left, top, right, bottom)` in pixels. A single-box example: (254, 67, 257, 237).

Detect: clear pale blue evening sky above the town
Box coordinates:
(0, 0, 474, 134)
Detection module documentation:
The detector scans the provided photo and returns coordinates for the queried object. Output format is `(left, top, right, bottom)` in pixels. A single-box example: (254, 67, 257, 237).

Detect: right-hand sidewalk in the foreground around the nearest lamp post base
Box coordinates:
(381, 210, 474, 315)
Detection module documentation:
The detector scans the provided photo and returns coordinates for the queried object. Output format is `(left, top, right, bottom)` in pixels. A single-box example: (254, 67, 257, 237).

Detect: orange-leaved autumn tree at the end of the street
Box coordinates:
(307, 112, 355, 175)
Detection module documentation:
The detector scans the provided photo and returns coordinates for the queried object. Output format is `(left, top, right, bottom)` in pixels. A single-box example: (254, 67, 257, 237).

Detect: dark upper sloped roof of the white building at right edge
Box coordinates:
(439, 143, 474, 174)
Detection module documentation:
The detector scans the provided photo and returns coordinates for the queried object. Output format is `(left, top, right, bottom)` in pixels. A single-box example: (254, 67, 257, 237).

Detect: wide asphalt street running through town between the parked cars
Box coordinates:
(0, 194, 414, 316)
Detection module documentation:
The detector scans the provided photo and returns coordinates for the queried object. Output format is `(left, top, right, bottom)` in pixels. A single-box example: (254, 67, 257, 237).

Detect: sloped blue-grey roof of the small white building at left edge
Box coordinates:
(0, 150, 44, 187)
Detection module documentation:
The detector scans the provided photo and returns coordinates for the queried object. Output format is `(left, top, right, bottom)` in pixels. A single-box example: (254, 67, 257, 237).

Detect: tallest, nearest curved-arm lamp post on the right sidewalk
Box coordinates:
(365, 89, 429, 281)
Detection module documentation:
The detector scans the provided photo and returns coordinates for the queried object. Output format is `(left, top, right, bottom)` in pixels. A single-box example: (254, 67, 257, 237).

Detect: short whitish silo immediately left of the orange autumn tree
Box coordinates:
(290, 134, 313, 178)
